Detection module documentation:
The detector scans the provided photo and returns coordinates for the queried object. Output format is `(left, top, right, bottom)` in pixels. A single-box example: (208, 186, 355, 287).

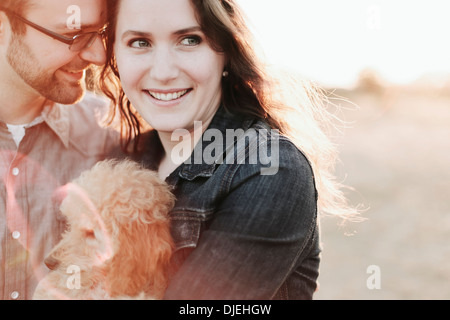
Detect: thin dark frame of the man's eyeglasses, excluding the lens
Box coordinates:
(0, 6, 108, 52)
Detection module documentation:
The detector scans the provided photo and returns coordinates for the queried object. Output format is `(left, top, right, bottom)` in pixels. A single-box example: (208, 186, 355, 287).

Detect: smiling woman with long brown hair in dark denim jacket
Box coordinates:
(102, 0, 356, 299)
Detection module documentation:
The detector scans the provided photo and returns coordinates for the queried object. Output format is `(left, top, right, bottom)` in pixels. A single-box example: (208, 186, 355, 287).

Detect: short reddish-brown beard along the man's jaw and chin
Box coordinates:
(7, 35, 86, 104)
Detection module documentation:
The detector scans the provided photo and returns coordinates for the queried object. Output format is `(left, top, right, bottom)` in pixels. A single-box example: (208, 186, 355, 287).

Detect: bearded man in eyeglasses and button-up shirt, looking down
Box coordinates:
(0, 0, 116, 300)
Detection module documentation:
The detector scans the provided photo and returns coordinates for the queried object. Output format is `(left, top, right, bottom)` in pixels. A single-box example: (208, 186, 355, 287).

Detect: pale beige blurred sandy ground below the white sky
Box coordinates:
(315, 87, 450, 300)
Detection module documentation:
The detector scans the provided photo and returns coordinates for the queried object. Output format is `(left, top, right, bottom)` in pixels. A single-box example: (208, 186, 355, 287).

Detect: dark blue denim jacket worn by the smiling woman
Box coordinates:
(128, 107, 320, 300)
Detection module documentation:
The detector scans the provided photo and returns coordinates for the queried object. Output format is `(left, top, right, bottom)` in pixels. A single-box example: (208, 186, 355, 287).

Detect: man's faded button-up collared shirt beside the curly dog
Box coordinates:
(0, 93, 118, 300)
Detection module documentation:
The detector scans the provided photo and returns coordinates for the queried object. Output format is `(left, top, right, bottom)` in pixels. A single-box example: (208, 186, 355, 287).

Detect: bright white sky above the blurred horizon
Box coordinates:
(237, 0, 450, 86)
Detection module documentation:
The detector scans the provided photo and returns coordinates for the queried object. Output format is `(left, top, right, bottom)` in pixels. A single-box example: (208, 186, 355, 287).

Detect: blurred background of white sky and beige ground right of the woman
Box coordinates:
(238, 0, 450, 300)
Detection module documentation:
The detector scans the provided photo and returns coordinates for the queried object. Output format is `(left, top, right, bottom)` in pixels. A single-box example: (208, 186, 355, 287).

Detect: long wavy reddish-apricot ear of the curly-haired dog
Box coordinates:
(106, 212, 173, 299)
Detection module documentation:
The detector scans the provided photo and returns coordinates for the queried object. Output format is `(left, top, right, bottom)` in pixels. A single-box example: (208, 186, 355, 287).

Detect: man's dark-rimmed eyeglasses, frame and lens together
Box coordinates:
(0, 6, 107, 52)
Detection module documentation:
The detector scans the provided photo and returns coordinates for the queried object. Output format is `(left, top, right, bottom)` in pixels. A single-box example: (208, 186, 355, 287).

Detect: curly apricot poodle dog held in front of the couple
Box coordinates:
(33, 160, 174, 300)
